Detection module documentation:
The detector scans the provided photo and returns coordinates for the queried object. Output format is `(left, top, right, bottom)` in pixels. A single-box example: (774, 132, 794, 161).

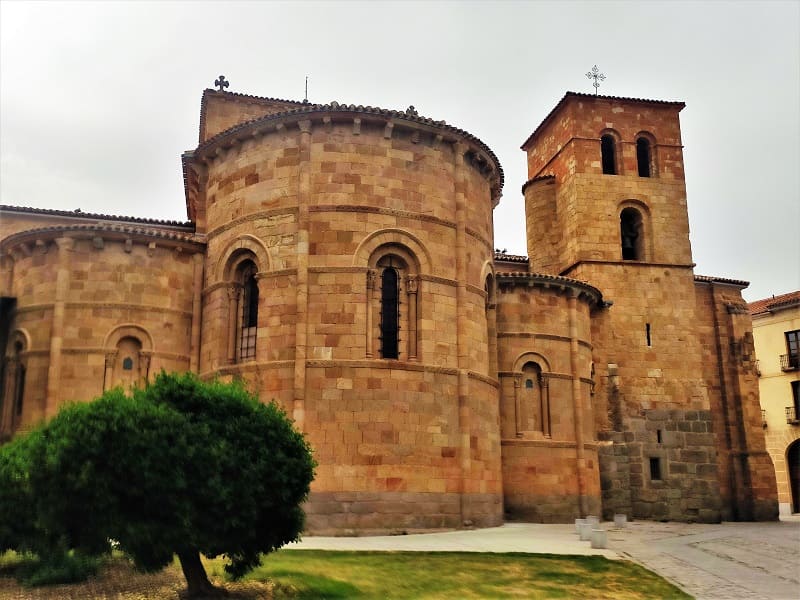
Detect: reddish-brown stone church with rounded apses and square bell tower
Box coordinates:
(0, 89, 777, 534)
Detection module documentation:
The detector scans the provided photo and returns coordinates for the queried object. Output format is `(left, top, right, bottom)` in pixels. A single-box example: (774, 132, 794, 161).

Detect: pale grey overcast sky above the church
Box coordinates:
(0, 0, 800, 301)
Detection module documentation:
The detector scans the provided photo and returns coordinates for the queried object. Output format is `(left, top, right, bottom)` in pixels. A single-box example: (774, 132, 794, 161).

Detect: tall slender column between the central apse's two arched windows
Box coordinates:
(292, 119, 311, 431)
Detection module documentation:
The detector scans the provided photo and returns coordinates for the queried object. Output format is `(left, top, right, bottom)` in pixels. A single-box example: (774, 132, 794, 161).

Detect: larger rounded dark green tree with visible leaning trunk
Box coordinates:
(0, 373, 314, 596)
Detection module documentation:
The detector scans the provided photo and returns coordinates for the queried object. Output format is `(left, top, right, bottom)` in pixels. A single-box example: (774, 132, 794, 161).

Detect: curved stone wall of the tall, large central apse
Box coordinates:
(189, 101, 502, 533)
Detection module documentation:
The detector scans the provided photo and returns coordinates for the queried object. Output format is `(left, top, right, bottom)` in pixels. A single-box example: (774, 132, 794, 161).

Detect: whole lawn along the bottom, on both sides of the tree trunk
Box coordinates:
(0, 550, 691, 600)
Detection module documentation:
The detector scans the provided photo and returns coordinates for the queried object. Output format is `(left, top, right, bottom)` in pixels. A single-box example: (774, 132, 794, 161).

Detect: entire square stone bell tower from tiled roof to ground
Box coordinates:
(522, 92, 776, 521)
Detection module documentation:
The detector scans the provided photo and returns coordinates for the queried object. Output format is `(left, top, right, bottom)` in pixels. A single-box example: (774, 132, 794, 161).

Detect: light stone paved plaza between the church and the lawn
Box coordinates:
(289, 516, 800, 600)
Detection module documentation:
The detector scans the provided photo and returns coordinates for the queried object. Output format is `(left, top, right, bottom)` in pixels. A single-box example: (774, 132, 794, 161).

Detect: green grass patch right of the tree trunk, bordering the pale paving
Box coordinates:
(220, 550, 691, 600)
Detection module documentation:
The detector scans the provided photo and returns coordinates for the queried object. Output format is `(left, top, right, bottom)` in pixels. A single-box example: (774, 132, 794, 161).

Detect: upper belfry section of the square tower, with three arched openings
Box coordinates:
(522, 92, 692, 274)
